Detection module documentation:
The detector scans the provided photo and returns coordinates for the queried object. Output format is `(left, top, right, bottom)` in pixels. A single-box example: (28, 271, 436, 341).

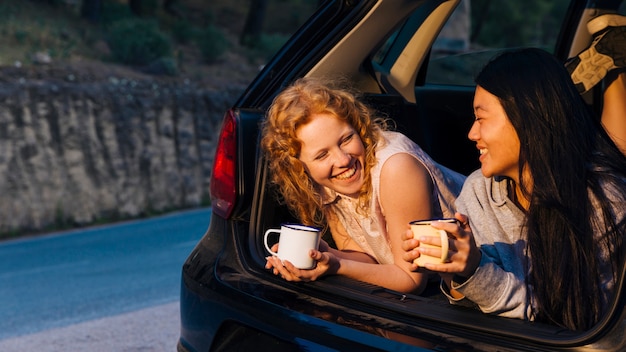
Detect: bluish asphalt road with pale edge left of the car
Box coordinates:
(0, 208, 211, 351)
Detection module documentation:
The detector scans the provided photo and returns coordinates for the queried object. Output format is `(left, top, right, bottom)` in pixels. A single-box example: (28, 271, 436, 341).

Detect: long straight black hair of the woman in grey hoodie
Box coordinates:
(476, 48, 626, 330)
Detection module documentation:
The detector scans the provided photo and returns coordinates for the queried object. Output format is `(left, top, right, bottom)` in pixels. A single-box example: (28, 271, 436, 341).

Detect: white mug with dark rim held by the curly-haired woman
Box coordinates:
(263, 224, 320, 269)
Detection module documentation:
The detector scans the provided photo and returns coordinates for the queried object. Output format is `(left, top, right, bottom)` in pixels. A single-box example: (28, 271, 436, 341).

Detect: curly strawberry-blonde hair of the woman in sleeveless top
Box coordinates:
(261, 78, 387, 229)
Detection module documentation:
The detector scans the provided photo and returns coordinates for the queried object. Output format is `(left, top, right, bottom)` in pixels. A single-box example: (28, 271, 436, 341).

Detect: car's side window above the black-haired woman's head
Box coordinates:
(426, 0, 569, 85)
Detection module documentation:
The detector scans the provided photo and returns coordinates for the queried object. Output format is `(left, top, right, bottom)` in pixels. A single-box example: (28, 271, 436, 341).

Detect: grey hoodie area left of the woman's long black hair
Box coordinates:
(452, 170, 531, 319)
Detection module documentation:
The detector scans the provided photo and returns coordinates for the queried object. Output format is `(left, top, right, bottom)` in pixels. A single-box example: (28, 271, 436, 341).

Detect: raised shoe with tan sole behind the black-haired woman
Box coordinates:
(565, 24, 626, 94)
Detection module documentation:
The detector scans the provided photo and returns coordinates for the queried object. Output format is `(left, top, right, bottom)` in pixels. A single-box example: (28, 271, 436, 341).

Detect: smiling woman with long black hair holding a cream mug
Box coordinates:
(403, 49, 626, 330)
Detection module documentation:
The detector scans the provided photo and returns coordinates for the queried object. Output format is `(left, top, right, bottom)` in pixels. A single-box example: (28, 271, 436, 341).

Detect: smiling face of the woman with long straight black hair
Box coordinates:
(468, 86, 520, 182)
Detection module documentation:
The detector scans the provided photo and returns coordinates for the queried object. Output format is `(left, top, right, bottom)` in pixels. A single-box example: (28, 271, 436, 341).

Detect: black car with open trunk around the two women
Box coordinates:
(178, 0, 626, 351)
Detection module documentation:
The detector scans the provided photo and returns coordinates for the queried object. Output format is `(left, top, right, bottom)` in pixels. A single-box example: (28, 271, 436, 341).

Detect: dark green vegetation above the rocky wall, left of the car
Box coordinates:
(0, 0, 316, 74)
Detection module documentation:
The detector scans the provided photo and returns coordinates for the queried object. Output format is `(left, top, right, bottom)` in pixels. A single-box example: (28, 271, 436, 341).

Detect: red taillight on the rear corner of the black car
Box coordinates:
(210, 110, 237, 218)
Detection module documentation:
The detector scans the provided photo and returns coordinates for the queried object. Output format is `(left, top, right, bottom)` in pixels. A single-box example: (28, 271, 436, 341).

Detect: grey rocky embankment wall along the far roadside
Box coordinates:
(0, 61, 254, 233)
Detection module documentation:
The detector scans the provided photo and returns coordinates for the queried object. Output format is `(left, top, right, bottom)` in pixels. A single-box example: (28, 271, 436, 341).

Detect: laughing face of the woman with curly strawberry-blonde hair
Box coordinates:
(296, 114, 365, 197)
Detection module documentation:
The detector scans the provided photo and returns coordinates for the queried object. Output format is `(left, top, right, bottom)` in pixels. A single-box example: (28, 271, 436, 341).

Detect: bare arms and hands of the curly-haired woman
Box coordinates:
(268, 154, 432, 293)
